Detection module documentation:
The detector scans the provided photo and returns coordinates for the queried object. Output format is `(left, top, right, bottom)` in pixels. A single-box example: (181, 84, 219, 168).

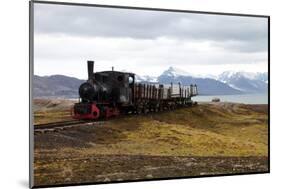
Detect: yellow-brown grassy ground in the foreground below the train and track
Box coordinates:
(32, 100, 268, 185)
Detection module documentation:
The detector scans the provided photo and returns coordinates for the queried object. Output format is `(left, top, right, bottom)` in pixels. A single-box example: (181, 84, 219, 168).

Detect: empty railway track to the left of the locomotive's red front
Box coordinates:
(34, 120, 93, 132)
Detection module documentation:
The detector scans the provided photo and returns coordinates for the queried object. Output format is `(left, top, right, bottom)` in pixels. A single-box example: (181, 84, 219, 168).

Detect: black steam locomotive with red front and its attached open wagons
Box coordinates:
(72, 61, 198, 119)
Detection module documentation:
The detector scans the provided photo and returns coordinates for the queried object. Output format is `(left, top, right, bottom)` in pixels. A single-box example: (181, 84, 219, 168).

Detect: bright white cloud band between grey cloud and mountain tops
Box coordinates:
(35, 35, 267, 78)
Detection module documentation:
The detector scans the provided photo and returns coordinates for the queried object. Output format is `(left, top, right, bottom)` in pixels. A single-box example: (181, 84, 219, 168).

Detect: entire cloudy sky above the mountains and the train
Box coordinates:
(34, 3, 268, 79)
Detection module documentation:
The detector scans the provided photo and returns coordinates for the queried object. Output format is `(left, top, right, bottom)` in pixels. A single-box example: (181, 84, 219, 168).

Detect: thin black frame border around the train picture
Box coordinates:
(29, 0, 271, 188)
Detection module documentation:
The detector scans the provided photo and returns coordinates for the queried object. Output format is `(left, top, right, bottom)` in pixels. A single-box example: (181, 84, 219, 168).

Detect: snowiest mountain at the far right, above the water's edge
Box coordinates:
(218, 71, 268, 93)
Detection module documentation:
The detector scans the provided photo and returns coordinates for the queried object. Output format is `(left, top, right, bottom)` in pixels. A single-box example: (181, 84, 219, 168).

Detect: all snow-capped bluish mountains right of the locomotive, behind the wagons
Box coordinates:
(136, 67, 268, 95)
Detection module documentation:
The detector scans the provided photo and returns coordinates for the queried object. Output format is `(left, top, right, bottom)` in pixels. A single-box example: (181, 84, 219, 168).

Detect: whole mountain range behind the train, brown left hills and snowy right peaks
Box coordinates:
(33, 67, 268, 98)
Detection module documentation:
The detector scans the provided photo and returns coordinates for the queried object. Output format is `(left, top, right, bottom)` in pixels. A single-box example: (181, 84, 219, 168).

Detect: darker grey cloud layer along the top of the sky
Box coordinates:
(35, 4, 267, 52)
